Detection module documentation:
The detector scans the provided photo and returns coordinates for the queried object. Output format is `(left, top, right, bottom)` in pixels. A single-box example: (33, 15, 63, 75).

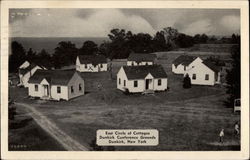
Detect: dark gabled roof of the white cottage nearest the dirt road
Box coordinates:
(29, 69, 79, 85)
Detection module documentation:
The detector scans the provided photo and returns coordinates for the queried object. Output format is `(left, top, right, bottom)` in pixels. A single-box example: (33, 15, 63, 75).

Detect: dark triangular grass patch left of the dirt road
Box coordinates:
(8, 103, 65, 151)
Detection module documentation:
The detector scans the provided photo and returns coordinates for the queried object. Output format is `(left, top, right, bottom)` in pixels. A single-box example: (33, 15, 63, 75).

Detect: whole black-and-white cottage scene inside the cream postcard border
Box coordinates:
(0, 0, 249, 159)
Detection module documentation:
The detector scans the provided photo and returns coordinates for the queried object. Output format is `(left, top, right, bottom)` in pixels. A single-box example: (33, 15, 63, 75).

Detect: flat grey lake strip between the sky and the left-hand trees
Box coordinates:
(10, 37, 109, 54)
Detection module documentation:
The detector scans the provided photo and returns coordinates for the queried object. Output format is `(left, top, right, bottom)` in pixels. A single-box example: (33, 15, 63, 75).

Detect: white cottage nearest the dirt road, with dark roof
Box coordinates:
(28, 70, 84, 101)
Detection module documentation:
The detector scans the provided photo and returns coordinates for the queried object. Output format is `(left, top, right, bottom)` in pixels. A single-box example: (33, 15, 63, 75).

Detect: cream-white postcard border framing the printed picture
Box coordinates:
(1, 1, 249, 160)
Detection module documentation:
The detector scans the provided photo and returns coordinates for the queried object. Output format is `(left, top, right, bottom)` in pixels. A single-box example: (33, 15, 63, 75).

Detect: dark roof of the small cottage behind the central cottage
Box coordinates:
(128, 53, 156, 63)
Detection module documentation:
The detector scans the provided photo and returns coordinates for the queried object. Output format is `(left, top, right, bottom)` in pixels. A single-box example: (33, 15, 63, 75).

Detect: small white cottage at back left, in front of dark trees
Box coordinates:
(76, 55, 108, 72)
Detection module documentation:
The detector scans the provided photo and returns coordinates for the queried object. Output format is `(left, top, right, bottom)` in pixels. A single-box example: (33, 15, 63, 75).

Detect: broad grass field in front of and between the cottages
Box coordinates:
(9, 52, 240, 151)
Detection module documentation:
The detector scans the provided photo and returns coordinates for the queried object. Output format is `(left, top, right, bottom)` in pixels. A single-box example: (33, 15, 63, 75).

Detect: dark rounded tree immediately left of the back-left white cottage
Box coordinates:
(52, 41, 78, 68)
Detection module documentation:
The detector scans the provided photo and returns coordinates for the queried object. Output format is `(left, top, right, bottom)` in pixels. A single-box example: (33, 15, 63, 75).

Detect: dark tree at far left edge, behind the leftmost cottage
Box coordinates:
(9, 41, 26, 72)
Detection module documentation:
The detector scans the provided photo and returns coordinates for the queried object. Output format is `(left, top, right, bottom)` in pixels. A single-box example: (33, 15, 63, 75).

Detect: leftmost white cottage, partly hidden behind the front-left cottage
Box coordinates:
(18, 61, 46, 87)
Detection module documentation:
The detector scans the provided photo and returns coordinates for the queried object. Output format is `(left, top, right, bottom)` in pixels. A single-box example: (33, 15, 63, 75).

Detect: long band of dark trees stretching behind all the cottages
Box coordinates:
(9, 27, 239, 72)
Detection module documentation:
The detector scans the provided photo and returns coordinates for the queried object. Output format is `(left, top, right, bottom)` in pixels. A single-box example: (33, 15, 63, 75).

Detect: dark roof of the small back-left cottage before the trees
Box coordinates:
(78, 55, 107, 65)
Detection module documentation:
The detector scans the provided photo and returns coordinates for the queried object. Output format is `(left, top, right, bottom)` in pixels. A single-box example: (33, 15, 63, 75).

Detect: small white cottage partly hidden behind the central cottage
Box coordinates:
(127, 53, 156, 66)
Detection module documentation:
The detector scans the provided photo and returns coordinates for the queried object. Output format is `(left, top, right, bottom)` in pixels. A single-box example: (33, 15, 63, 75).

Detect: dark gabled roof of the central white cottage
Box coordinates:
(123, 65, 167, 80)
